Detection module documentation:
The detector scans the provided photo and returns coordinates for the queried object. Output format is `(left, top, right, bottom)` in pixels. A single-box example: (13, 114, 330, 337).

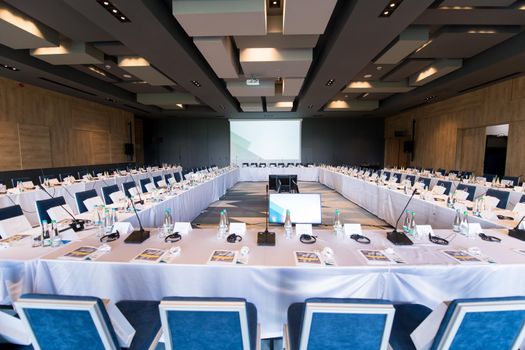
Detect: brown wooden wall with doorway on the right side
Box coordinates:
(385, 77, 525, 176)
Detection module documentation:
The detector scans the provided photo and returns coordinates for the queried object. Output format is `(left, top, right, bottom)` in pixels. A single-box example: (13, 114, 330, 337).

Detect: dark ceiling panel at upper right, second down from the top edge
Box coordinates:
(411, 27, 519, 58)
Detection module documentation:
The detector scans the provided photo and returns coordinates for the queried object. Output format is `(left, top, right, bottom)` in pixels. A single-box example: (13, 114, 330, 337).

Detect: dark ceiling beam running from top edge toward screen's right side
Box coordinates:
(297, 0, 434, 115)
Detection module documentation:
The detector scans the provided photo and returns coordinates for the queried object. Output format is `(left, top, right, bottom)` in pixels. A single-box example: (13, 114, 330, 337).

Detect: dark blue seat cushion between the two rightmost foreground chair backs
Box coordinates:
(390, 304, 432, 350)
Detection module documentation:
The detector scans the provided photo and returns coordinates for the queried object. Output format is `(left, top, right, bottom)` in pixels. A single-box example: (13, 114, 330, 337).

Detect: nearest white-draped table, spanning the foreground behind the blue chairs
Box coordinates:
(10, 227, 525, 338)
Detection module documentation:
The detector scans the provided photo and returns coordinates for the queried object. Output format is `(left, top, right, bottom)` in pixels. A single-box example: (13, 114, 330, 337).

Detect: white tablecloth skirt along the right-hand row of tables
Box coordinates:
(319, 168, 517, 229)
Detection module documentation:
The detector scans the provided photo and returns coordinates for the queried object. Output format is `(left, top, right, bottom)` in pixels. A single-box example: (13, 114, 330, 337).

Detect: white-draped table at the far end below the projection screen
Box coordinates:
(239, 166, 319, 182)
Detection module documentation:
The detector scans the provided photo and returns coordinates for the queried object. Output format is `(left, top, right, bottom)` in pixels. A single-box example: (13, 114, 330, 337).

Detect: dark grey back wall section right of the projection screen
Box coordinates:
(301, 118, 385, 165)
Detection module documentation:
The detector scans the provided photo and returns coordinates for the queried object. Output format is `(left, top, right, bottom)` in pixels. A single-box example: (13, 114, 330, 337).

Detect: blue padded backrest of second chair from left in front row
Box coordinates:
(163, 297, 257, 350)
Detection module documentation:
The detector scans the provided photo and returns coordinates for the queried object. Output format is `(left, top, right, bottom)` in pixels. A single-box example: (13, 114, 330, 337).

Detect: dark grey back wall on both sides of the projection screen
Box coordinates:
(144, 118, 385, 168)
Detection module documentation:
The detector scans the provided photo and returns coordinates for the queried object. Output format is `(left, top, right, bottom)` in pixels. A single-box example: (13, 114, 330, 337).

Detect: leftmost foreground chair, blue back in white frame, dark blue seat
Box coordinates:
(15, 294, 160, 350)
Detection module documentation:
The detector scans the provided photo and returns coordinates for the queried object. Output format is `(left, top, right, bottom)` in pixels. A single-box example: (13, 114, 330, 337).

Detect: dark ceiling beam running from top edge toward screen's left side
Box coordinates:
(64, 0, 238, 115)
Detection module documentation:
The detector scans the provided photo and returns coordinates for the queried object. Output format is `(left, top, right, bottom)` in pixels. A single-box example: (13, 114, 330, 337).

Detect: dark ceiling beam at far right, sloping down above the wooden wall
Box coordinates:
(380, 32, 525, 117)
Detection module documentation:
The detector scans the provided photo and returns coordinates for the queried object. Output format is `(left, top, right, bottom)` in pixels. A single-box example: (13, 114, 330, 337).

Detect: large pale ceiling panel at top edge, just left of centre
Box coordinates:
(172, 0, 266, 37)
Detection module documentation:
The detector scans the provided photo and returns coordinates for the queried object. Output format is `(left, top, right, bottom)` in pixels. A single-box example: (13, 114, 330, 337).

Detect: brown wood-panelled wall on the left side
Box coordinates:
(0, 78, 135, 171)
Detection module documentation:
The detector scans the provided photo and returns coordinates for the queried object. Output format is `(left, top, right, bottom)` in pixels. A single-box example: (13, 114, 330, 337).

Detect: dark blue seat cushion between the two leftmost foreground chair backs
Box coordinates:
(116, 300, 161, 350)
